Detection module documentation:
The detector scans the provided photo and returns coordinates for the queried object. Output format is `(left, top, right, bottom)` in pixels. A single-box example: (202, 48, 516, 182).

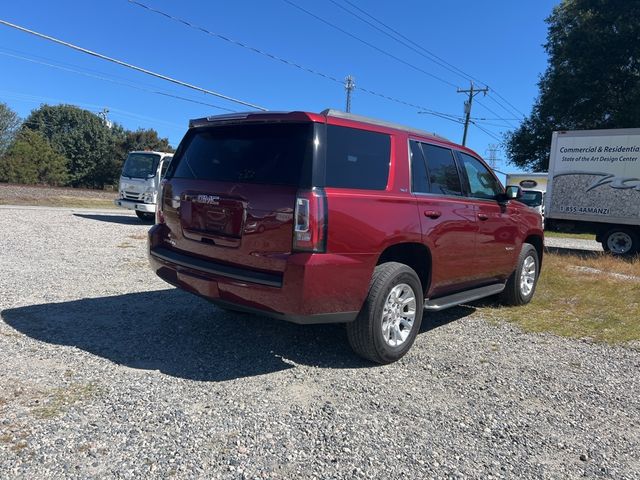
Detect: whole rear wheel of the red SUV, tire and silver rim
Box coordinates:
(347, 262, 424, 364)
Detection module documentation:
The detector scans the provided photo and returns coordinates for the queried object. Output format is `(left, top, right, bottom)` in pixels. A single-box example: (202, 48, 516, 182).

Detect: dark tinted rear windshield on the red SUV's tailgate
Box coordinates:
(167, 123, 313, 186)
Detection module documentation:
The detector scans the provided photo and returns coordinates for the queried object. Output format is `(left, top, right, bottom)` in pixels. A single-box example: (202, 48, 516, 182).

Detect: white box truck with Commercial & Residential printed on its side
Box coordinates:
(546, 128, 640, 255)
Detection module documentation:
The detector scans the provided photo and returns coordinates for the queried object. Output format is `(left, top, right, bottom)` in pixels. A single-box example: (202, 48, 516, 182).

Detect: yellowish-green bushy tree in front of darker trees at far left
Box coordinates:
(0, 128, 67, 186)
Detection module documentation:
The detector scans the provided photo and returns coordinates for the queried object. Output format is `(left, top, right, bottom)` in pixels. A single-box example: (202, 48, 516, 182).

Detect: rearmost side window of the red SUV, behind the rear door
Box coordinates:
(325, 125, 391, 190)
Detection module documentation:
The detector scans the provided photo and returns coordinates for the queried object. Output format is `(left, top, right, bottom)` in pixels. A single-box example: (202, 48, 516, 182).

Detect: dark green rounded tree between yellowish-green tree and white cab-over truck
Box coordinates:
(24, 105, 115, 188)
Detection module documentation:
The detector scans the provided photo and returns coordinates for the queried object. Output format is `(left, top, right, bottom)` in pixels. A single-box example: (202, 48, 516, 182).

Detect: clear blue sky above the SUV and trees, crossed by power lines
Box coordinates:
(0, 0, 558, 176)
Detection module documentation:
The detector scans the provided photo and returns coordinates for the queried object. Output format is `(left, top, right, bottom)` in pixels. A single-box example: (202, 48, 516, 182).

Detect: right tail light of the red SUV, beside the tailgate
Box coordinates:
(293, 188, 327, 253)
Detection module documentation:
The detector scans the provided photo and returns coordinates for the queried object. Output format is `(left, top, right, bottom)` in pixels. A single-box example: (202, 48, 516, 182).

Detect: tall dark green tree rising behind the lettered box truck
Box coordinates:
(505, 0, 640, 170)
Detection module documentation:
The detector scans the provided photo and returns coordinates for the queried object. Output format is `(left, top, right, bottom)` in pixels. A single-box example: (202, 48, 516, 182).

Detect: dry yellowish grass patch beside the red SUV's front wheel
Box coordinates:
(482, 254, 640, 343)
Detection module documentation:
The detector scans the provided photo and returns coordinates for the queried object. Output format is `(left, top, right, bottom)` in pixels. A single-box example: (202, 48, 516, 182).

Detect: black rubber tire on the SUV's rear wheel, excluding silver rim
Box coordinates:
(347, 262, 424, 364)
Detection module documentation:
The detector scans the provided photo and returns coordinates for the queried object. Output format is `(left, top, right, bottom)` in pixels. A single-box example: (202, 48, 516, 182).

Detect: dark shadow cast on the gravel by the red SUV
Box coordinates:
(1, 290, 475, 381)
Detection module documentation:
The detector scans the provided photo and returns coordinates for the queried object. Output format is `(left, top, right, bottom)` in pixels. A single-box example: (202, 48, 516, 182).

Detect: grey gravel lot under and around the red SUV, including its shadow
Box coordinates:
(0, 208, 640, 479)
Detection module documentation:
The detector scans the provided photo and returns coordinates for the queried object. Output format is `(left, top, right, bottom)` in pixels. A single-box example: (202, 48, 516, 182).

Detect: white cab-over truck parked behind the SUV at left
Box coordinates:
(114, 151, 173, 221)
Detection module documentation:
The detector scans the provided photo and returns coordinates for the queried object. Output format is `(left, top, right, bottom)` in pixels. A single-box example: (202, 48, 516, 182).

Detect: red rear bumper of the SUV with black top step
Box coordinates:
(149, 225, 375, 324)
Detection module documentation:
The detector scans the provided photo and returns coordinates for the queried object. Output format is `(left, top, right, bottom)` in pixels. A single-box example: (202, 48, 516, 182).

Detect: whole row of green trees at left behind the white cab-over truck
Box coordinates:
(0, 103, 173, 188)
